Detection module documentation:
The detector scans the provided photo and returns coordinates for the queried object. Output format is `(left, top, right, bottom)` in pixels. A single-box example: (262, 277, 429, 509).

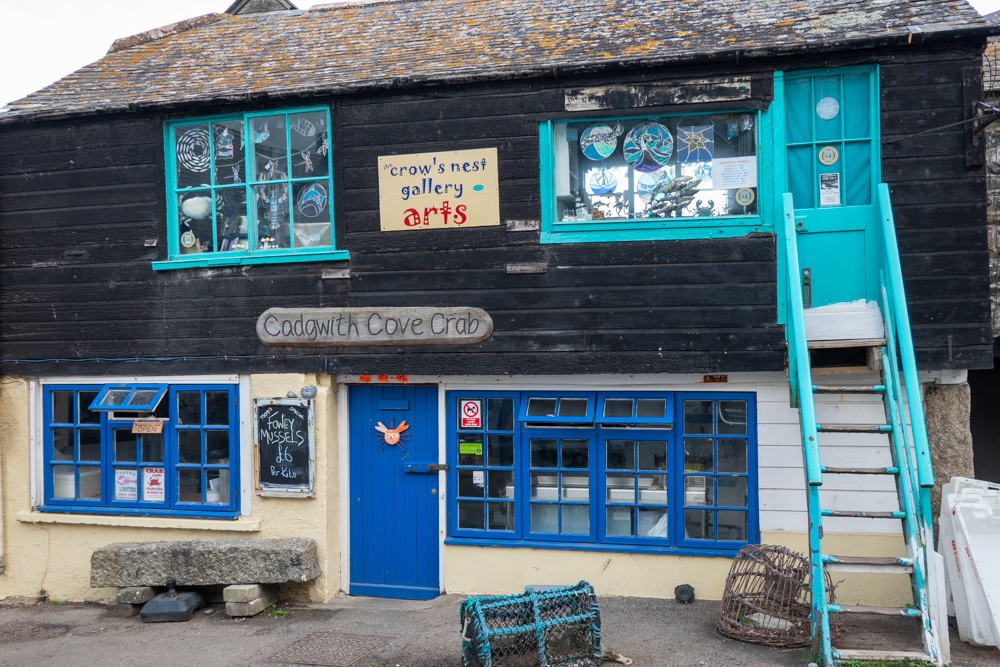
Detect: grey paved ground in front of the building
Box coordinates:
(0, 596, 1000, 667)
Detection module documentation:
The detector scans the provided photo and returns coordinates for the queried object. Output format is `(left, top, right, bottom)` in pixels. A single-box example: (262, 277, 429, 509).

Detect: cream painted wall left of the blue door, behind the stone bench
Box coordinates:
(0, 374, 340, 601)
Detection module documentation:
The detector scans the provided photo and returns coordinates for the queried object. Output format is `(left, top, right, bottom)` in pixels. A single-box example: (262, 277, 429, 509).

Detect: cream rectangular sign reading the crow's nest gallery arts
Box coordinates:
(378, 148, 500, 232)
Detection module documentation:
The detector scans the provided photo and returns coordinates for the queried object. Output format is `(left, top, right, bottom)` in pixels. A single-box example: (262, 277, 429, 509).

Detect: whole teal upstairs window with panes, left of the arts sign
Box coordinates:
(153, 107, 349, 269)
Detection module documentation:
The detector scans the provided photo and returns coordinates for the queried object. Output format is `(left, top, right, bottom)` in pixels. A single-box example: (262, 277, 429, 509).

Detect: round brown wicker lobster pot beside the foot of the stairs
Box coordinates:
(718, 544, 843, 647)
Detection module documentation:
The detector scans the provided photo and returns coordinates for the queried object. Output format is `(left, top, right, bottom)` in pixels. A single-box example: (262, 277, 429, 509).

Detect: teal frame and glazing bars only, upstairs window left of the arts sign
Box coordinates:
(152, 106, 350, 271)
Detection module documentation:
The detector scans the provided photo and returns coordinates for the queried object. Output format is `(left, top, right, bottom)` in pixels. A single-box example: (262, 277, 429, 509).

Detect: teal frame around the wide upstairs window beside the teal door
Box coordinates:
(538, 109, 777, 243)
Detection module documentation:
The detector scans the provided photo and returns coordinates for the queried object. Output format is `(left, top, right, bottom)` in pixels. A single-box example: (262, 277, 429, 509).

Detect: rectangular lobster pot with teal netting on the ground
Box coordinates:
(461, 581, 601, 667)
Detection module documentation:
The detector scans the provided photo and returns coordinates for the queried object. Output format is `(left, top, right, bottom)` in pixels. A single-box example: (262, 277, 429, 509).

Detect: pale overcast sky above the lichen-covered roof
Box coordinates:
(0, 0, 1000, 107)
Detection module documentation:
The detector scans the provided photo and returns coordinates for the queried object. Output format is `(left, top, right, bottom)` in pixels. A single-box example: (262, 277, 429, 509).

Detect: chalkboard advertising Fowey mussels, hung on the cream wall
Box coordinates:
(253, 398, 316, 497)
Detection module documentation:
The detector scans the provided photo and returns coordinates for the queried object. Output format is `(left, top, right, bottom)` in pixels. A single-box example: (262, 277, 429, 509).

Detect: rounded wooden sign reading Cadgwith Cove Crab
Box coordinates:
(257, 307, 493, 347)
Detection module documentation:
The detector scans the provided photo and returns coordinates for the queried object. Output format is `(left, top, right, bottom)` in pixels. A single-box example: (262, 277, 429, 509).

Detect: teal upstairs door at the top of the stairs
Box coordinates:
(775, 67, 881, 308)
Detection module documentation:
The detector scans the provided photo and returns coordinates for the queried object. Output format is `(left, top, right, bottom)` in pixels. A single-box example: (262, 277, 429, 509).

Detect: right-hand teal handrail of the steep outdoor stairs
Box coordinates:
(878, 183, 934, 489)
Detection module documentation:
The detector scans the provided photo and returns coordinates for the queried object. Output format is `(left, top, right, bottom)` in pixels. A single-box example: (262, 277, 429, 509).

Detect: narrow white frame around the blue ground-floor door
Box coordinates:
(332, 384, 448, 595)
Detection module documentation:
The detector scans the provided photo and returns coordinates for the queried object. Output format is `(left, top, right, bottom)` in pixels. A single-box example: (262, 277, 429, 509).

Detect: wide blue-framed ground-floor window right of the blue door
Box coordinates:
(447, 391, 758, 556)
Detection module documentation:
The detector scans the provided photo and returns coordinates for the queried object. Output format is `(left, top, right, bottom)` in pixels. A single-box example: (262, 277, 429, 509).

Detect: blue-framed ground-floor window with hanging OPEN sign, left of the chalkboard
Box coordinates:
(39, 385, 239, 517)
